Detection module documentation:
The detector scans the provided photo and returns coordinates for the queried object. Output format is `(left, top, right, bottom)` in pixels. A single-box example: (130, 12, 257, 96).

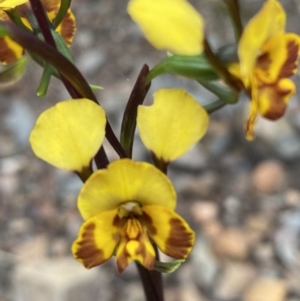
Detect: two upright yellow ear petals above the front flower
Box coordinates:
(30, 89, 209, 172)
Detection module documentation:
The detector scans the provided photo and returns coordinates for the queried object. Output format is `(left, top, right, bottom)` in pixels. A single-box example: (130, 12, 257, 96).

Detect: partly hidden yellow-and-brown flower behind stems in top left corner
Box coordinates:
(0, 0, 76, 65)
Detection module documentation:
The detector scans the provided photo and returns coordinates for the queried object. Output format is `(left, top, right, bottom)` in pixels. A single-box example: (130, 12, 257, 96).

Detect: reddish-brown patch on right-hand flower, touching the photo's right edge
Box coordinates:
(278, 41, 299, 79)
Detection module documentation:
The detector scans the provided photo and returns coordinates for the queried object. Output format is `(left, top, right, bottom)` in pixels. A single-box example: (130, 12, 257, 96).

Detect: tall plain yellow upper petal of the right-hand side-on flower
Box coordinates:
(238, 0, 286, 82)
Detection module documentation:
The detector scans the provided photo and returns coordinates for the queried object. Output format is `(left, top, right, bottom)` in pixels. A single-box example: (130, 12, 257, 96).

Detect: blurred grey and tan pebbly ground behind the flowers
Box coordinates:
(0, 0, 300, 301)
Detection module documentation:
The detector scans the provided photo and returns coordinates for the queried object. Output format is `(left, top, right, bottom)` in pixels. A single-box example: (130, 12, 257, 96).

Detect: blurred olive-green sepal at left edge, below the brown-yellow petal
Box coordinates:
(0, 56, 28, 84)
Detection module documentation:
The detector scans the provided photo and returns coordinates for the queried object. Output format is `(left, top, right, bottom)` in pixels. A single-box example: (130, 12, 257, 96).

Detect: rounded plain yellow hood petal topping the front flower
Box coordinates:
(78, 159, 176, 219)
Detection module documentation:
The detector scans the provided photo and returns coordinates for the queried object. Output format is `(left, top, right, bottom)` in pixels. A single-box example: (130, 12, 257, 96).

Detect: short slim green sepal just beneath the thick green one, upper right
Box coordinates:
(198, 80, 239, 104)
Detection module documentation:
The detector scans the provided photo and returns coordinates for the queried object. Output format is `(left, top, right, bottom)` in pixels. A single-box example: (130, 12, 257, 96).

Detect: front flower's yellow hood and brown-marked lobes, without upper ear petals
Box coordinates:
(72, 159, 194, 273)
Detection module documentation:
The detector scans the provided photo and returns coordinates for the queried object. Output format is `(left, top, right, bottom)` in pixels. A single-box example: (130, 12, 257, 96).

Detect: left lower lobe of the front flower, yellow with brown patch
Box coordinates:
(72, 210, 121, 269)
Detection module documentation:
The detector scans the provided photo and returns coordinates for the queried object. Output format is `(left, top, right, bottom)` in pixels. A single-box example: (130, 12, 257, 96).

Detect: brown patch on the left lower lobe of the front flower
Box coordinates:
(74, 223, 108, 269)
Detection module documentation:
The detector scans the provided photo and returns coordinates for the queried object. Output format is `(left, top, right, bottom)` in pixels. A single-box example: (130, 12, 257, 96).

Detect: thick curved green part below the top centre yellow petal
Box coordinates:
(146, 54, 219, 82)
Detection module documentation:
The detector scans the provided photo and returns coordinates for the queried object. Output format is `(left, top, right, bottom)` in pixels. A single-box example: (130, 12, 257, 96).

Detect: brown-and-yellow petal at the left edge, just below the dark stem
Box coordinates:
(0, 37, 24, 65)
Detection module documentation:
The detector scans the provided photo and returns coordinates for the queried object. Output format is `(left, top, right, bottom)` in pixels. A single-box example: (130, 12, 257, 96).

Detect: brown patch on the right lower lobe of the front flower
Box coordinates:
(164, 218, 194, 259)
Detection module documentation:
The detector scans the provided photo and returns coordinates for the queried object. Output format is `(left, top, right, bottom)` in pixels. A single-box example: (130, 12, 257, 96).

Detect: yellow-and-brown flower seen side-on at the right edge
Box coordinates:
(229, 0, 300, 140)
